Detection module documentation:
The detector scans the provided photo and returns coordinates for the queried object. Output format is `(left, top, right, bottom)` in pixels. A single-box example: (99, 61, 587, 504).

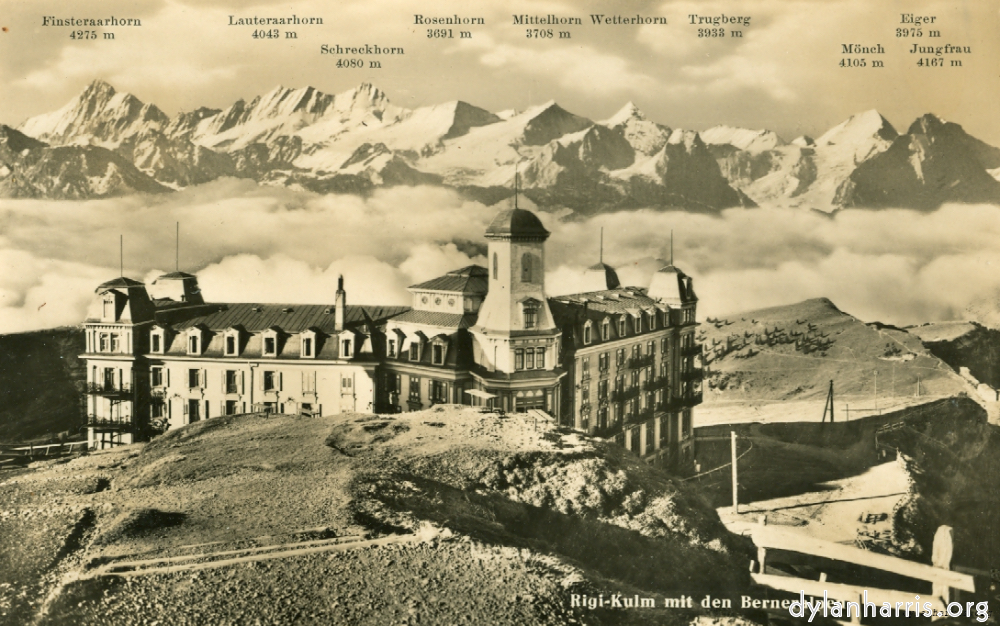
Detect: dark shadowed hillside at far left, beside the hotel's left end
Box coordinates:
(0, 328, 87, 442)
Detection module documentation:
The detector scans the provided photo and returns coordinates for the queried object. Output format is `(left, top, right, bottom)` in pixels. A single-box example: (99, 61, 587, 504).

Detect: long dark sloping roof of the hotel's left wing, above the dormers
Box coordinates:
(166, 303, 409, 333)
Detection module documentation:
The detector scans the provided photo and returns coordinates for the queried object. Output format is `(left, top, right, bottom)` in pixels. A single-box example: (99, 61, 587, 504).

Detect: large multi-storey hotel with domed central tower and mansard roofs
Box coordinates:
(81, 208, 701, 469)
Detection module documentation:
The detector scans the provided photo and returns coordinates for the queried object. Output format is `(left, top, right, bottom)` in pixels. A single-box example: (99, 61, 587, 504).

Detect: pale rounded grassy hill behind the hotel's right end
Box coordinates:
(698, 298, 970, 424)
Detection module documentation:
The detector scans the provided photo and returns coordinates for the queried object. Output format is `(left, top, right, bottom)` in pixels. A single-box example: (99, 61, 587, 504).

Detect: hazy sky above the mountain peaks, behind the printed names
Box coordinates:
(0, 0, 1000, 144)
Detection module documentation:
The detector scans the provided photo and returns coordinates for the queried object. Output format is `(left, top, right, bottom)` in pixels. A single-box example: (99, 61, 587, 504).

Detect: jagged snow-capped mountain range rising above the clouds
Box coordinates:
(0, 81, 1000, 208)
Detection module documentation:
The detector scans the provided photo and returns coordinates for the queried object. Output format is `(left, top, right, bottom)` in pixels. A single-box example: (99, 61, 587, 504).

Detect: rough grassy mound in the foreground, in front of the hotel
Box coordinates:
(0, 406, 749, 624)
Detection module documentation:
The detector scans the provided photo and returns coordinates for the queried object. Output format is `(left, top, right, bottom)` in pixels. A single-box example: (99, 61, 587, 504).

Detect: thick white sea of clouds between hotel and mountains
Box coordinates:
(0, 179, 1000, 333)
